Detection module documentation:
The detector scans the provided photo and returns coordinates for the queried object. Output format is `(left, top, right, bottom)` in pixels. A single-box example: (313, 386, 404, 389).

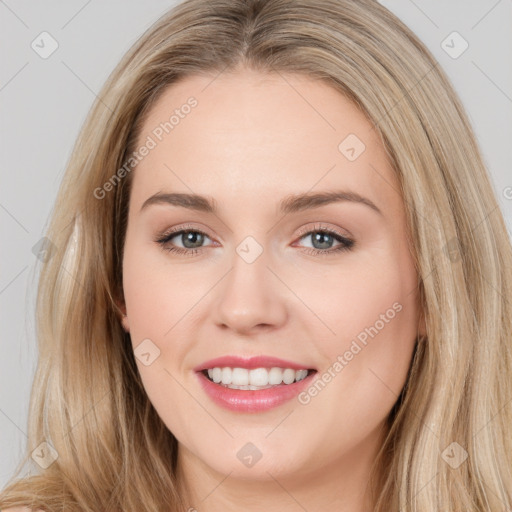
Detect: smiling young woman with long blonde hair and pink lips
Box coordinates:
(0, 0, 512, 512)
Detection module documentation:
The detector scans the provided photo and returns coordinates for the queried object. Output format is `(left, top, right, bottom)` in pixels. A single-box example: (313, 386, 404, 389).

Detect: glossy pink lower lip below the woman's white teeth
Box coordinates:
(196, 372, 317, 412)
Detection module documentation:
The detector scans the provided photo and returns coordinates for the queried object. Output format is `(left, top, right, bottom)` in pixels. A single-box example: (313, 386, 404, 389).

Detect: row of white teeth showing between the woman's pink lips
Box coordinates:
(201, 367, 316, 391)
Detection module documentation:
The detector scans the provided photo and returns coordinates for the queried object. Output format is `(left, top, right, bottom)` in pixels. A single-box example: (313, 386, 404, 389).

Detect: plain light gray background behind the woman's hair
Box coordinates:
(0, 0, 512, 487)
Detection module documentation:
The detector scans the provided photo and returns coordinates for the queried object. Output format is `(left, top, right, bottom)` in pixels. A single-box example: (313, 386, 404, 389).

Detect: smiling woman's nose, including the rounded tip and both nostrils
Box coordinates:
(213, 245, 288, 335)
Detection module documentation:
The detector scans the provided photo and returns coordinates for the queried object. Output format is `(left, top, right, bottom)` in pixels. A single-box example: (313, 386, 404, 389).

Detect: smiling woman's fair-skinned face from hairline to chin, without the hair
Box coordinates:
(123, 70, 423, 496)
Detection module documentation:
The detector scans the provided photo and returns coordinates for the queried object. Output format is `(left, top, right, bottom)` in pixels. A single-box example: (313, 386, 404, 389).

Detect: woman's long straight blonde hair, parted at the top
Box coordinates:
(0, 0, 512, 512)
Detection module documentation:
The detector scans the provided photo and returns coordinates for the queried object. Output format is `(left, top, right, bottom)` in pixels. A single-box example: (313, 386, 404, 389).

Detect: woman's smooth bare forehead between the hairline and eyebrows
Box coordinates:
(131, 70, 399, 216)
